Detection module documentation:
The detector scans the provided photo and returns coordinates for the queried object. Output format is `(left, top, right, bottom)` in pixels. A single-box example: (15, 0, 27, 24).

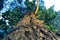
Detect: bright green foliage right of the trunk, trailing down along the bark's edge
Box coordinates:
(37, 6, 57, 33)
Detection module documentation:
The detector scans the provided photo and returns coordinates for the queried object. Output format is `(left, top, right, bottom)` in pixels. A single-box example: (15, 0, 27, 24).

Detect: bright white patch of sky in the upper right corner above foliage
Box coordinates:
(44, 0, 60, 11)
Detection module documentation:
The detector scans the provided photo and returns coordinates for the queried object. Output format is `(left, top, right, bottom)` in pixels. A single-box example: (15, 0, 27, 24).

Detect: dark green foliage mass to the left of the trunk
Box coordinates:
(0, 8, 23, 29)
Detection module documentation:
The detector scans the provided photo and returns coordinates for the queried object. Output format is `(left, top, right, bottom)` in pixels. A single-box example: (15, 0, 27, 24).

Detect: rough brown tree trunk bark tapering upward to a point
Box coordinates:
(3, 13, 58, 40)
